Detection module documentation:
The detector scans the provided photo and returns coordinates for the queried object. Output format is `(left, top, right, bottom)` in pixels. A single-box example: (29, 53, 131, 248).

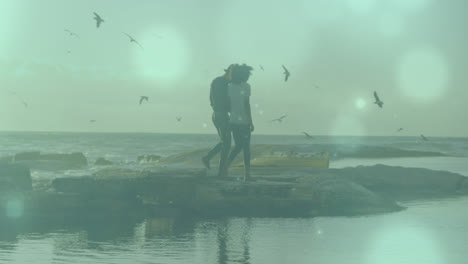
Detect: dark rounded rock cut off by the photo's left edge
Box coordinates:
(0, 162, 32, 194)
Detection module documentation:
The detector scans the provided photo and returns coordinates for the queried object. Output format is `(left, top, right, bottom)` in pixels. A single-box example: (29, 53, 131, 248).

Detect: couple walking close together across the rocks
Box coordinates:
(202, 64, 254, 181)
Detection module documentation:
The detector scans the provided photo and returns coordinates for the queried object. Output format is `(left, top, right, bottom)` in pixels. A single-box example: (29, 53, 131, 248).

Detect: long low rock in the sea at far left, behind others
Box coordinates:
(11, 152, 88, 171)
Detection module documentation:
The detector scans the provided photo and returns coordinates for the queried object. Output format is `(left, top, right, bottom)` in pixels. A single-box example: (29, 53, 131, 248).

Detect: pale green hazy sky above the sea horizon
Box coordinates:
(0, 0, 468, 137)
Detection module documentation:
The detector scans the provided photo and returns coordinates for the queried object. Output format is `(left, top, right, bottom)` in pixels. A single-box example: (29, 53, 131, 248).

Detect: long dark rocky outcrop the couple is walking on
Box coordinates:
(0, 165, 468, 221)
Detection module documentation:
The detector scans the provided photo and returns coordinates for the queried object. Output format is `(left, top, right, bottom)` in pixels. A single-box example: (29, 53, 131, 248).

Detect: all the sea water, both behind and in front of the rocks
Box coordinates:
(0, 132, 468, 264)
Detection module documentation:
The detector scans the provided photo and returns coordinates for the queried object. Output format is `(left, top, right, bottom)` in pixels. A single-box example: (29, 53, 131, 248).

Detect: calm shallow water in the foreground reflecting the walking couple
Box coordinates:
(0, 198, 468, 264)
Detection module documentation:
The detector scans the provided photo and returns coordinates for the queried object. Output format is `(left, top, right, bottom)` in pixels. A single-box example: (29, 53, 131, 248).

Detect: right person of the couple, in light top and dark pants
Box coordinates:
(225, 64, 254, 181)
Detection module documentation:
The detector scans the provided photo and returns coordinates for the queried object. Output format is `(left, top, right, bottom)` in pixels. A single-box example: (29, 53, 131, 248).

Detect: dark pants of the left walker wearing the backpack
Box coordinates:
(206, 112, 231, 174)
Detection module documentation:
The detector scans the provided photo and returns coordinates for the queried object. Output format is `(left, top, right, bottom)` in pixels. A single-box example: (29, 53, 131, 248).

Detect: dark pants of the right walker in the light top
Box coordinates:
(227, 124, 251, 176)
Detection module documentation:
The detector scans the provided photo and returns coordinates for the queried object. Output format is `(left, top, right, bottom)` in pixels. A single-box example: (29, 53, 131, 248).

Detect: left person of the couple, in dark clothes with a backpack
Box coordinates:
(202, 65, 232, 176)
